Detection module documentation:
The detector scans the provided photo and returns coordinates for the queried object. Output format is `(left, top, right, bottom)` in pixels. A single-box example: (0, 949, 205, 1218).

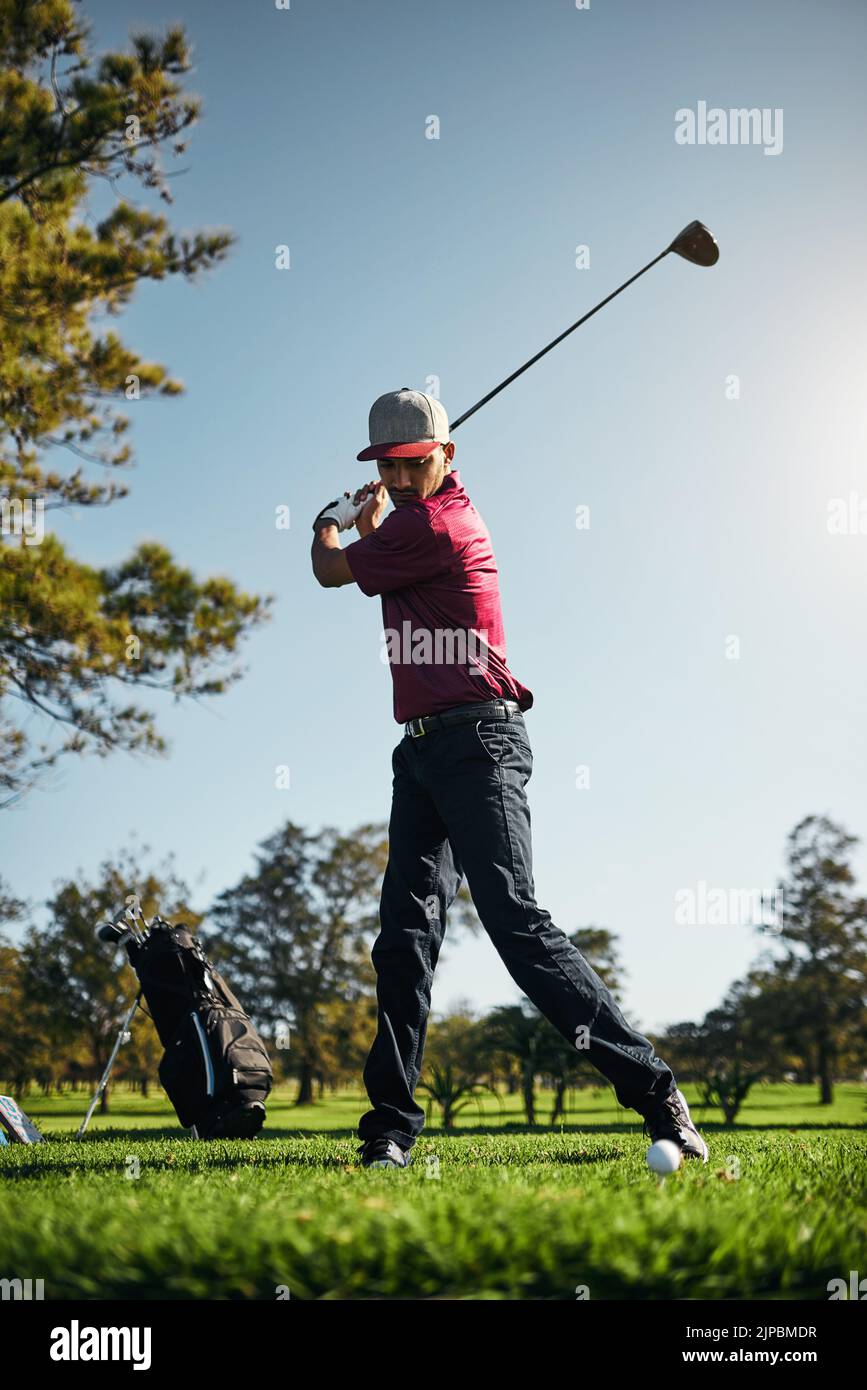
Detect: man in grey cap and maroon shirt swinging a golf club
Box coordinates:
(313, 386, 707, 1168)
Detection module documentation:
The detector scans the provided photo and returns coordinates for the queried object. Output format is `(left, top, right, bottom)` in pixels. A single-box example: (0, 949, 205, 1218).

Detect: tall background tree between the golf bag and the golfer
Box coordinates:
(207, 821, 388, 1105)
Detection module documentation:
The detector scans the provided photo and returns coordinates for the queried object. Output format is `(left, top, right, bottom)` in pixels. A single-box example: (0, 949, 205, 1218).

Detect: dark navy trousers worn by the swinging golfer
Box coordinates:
(358, 714, 674, 1148)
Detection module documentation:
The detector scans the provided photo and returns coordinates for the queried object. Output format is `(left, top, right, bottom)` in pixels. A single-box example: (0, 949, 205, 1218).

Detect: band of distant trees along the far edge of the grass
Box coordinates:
(0, 816, 867, 1127)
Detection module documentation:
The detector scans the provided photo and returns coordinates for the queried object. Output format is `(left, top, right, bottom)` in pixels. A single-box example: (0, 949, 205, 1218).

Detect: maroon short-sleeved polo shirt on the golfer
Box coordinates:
(343, 470, 534, 724)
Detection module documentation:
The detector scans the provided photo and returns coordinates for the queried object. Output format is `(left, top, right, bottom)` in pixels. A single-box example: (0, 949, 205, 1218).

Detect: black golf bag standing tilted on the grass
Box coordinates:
(126, 917, 274, 1138)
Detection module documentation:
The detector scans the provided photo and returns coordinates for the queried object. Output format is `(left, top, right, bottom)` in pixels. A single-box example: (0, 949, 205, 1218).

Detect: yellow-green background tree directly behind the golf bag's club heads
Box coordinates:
(21, 855, 195, 1113)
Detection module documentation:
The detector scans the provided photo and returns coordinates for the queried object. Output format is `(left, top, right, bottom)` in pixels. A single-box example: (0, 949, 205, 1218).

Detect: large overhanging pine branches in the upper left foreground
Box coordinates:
(0, 0, 270, 805)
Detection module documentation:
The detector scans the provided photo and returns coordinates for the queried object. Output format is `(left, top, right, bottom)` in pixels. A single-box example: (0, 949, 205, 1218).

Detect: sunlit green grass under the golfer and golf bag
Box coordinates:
(0, 1086, 867, 1300)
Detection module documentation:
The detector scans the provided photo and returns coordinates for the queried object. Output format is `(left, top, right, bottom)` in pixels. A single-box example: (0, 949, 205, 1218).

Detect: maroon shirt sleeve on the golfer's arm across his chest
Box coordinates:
(343, 506, 449, 598)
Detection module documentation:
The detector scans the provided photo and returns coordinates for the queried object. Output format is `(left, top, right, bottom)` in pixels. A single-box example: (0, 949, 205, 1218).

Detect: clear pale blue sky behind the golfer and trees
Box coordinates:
(0, 0, 867, 1027)
